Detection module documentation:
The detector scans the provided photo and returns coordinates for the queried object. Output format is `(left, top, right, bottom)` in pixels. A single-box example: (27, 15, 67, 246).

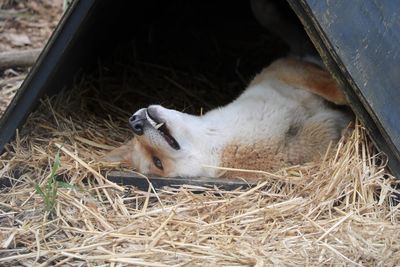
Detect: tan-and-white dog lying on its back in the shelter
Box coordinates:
(106, 58, 350, 178)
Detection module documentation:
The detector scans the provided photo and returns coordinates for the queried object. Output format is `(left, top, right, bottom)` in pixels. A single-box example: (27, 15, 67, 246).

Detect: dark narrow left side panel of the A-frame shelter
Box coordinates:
(0, 0, 95, 153)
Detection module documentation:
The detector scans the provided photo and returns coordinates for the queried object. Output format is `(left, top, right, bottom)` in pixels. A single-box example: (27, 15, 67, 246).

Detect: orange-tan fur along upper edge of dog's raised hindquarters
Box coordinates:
(250, 58, 348, 105)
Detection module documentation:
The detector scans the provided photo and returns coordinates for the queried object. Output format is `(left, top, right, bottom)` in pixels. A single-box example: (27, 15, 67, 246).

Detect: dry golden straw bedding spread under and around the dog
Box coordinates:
(0, 59, 400, 266)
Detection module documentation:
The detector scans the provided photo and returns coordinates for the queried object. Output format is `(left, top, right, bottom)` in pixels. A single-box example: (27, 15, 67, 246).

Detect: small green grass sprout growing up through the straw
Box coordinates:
(35, 150, 61, 212)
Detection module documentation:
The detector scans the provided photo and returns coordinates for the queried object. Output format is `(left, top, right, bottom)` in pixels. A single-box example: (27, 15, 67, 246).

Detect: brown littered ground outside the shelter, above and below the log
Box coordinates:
(0, 0, 63, 117)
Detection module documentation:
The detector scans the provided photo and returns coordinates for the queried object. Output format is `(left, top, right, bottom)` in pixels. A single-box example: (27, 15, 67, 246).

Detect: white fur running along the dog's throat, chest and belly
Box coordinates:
(144, 73, 343, 177)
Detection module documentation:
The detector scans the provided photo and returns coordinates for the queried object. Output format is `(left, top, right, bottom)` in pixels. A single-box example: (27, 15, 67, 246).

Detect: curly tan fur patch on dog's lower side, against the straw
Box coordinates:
(221, 118, 340, 178)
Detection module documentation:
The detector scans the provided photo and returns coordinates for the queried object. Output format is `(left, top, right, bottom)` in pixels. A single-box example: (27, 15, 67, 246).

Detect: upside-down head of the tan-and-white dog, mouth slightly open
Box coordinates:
(105, 105, 209, 177)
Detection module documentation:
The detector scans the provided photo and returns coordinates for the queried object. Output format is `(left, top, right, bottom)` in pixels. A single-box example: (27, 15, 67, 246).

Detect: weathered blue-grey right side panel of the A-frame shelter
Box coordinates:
(288, 0, 400, 180)
